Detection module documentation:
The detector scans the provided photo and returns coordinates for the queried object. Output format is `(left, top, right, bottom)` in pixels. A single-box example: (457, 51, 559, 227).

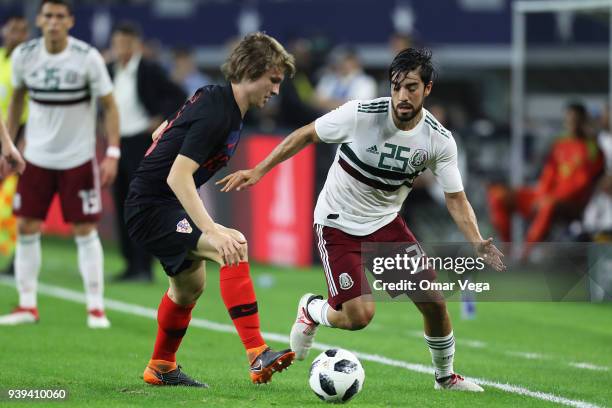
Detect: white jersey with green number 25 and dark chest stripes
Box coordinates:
(314, 97, 463, 236)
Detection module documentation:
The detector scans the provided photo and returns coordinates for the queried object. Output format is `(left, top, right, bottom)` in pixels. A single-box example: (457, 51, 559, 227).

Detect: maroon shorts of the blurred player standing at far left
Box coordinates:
(13, 159, 102, 223)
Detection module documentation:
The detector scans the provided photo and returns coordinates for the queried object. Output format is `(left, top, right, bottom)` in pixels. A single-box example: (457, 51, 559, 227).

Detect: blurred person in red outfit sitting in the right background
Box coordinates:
(487, 103, 603, 247)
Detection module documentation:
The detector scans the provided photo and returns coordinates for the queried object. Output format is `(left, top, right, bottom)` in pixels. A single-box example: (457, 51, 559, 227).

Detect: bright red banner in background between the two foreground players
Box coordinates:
(246, 135, 315, 266)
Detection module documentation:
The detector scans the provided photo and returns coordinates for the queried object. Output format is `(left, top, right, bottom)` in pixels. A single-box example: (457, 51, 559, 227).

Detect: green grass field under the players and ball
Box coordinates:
(0, 239, 612, 407)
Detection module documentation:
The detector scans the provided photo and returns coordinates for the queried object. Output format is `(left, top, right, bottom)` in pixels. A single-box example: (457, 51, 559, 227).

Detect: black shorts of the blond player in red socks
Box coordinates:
(124, 205, 202, 276)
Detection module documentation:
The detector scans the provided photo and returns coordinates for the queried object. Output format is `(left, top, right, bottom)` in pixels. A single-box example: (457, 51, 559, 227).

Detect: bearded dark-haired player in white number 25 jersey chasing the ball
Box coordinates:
(219, 48, 505, 391)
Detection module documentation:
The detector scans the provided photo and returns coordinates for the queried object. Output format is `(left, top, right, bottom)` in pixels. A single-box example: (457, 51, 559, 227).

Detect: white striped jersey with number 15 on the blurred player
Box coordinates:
(12, 37, 113, 170)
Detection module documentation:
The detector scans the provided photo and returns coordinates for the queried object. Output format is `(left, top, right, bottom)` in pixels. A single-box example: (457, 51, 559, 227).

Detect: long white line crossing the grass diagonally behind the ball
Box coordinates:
(0, 277, 601, 408)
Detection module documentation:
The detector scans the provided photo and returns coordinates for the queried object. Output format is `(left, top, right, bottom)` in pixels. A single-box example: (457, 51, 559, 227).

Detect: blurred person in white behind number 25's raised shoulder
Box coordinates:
(315, 47, 376, 111)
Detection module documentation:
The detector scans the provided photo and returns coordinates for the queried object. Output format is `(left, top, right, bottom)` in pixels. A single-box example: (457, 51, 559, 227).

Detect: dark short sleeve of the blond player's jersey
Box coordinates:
(179, 114, 228, 165)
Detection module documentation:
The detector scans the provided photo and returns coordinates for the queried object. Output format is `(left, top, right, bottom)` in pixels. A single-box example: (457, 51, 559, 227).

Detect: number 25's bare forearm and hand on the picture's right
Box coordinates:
(444, 191, 506, 271)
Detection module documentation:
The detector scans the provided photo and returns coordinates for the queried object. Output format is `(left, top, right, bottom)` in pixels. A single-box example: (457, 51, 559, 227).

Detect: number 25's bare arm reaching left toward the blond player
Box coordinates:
(215, 122, 321, 192)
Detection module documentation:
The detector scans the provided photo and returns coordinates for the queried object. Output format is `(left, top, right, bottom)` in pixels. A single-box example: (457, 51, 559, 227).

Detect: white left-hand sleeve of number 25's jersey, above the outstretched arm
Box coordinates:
(315, 101, 358, 143)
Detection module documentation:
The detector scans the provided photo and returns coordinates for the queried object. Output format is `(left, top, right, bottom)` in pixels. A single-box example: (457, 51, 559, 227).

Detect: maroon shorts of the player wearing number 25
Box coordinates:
(315, 215, 436, 310)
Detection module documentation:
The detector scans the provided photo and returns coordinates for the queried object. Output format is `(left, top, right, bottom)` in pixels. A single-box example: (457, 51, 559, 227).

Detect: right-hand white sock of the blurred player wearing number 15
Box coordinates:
(75, 230, 104, 310)
